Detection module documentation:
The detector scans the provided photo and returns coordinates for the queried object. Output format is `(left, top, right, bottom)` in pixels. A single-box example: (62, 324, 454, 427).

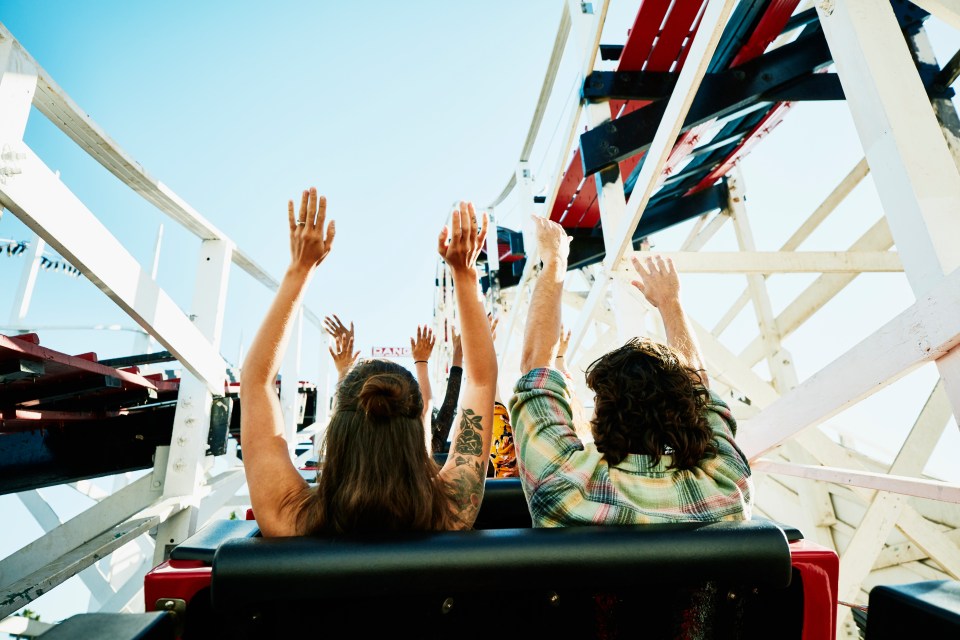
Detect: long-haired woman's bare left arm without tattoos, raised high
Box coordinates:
(240, 187, 335, 536)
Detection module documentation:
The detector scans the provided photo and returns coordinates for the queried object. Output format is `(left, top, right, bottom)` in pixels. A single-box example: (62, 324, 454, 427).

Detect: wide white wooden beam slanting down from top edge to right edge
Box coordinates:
(817, 0, 960, 295)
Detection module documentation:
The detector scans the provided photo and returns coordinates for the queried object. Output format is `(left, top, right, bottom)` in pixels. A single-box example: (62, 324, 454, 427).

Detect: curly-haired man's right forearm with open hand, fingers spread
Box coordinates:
(633, 255, 709, 386)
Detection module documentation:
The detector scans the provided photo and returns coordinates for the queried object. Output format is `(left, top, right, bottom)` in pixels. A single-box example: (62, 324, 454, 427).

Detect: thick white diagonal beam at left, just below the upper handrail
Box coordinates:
(0, 147, 226, 393)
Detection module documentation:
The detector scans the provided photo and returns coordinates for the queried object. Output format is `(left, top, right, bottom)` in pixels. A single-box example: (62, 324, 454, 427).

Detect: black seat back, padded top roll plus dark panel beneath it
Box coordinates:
(210, 521, 802, 640)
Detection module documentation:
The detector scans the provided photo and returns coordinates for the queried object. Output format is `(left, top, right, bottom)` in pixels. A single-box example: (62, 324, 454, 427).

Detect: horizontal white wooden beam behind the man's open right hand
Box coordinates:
(616, 251, 903, 277)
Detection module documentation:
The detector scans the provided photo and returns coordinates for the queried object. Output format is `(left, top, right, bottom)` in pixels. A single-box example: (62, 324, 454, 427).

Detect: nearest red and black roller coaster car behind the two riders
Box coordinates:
(144, 478, 839, 640)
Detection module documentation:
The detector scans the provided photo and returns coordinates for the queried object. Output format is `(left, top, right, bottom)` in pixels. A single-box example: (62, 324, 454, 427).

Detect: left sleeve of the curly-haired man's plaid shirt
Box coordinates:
(510, 368, 583, 488)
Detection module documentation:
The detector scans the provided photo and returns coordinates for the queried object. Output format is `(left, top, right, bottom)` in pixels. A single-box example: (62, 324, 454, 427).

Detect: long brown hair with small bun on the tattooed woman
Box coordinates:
(298, 360, 453, 535)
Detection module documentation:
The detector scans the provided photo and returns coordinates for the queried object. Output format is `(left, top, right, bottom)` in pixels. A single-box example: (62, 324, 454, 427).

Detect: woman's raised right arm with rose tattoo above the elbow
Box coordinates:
(438, 202, 497, 528)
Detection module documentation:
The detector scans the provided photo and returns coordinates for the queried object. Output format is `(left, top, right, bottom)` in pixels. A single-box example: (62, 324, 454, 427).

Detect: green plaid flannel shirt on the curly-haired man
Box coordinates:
(510, 369, 753, 527)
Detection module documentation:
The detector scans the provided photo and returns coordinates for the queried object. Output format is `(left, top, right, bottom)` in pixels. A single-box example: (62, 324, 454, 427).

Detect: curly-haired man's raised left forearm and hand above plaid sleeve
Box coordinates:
(520, 216, 570, 374)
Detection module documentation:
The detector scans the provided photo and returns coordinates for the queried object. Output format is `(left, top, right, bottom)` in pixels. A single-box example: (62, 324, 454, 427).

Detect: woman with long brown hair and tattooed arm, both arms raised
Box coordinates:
(240, 188, 497, 536)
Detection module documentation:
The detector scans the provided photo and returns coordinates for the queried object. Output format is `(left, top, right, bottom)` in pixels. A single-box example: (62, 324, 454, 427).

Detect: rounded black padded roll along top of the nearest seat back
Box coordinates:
(211, 521, 791, 609)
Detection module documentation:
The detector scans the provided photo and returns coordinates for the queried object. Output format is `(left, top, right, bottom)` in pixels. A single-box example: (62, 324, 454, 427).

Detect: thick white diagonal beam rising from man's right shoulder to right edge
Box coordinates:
(737, 269, 960, 460)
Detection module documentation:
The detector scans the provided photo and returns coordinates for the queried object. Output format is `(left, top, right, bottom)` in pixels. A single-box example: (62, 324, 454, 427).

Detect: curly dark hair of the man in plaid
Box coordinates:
(586, 338, 717, 469)
